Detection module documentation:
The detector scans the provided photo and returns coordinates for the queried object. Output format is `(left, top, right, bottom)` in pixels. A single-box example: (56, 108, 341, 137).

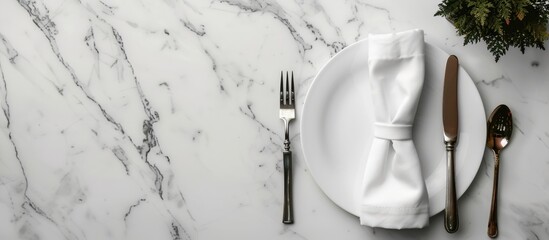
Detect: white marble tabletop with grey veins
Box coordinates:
(0, 0, 549, 240)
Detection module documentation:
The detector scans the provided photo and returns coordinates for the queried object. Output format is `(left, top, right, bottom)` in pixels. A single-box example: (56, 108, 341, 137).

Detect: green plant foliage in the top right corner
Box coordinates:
(435, 0, 549, 62)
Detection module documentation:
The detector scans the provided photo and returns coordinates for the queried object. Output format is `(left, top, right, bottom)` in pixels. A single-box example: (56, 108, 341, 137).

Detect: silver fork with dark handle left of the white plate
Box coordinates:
(280, 71, 295, 224)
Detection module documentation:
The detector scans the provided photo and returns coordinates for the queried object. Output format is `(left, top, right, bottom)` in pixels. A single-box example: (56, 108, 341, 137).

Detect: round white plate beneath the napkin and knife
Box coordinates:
(300, 40, 486, 216)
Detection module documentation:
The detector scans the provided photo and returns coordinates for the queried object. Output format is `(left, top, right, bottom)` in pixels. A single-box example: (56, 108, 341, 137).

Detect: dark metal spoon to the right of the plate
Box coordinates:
(486, 104, 513, 238)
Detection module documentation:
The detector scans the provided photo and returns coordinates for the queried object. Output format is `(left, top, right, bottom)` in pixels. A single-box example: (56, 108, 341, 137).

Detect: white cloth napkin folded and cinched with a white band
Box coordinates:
(358, 30, 429, 229)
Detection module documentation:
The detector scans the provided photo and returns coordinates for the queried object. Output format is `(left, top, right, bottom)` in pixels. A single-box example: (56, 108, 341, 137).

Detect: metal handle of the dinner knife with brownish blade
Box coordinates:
(444, 142, 459, 233)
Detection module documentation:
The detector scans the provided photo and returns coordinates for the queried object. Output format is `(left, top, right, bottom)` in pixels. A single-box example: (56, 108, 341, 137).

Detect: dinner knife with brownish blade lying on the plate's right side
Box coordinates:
(442, 55, 459, 233)
